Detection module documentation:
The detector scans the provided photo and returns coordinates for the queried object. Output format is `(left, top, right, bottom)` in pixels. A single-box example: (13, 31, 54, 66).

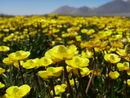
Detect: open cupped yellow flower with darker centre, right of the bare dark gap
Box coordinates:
(104, 53, 121, 63)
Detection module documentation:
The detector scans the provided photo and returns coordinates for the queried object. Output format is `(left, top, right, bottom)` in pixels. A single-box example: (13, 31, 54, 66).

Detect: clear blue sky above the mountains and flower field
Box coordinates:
(0, 0, 111, 15)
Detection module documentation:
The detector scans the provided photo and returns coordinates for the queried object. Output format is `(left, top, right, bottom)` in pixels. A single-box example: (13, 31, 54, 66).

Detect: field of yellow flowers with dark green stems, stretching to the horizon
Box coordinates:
(0, 15, 130, 98)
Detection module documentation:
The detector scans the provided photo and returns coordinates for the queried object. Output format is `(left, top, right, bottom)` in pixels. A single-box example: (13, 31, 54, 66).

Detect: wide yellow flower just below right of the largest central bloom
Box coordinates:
(65, 56, 89, 68)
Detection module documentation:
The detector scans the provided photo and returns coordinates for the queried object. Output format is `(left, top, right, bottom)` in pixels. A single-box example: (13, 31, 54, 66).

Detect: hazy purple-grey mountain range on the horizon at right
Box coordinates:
(53, 0, 130, 16)
